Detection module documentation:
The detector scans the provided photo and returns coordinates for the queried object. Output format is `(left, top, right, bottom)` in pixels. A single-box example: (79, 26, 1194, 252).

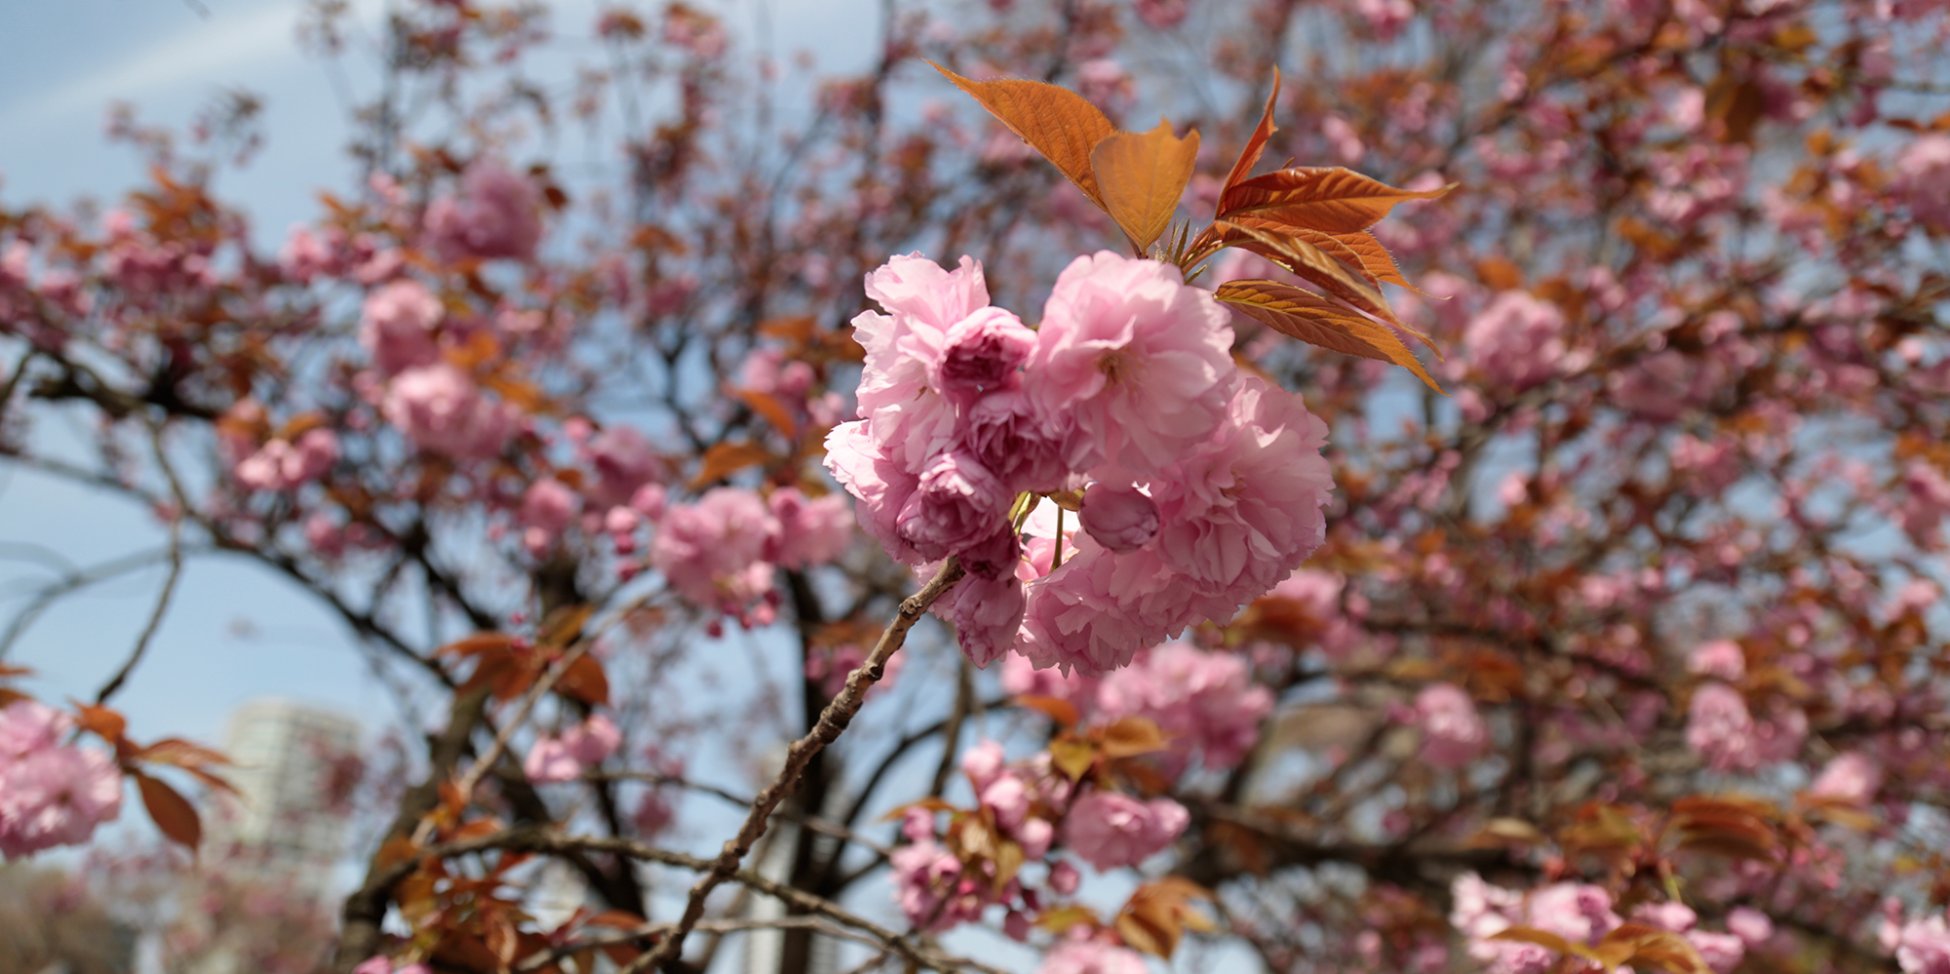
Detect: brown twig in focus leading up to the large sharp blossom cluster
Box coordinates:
(622, 558, 961, 974)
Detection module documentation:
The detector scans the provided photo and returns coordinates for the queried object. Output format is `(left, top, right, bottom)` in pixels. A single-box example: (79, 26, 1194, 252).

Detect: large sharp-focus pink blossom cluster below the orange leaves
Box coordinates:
(827, 252, 1332, 673)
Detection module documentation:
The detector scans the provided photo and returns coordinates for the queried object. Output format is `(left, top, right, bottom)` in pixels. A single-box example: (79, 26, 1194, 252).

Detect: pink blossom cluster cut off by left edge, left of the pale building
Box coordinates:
(0, 699, 123, 859)
